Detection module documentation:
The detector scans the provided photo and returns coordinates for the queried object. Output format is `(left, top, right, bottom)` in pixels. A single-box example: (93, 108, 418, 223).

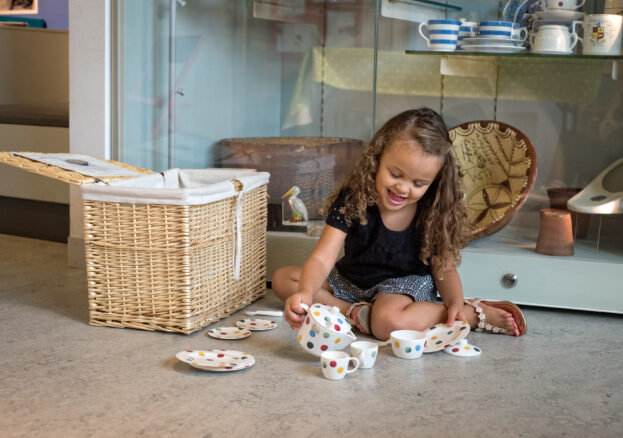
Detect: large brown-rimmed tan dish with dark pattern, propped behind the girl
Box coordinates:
(450, 121, 537, 240)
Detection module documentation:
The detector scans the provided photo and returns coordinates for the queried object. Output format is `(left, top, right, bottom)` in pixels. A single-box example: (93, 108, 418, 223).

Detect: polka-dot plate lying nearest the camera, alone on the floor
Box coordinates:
(175, 350, 255, 372)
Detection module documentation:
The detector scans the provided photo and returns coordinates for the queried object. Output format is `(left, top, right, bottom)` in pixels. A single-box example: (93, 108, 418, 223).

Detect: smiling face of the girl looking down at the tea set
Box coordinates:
(376, 139, 443, 213)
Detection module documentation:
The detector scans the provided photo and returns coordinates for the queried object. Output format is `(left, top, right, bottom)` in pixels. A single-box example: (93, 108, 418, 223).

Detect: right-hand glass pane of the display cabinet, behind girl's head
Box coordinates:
(375, 1, 623, 263)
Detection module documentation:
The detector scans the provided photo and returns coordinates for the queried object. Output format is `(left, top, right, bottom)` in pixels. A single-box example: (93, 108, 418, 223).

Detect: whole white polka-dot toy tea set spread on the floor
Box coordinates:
(176, 303, 481, 380)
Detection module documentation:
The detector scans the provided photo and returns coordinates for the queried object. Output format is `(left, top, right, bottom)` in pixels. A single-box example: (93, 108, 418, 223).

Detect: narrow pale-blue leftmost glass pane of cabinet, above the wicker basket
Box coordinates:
(115, 0, 169, 171)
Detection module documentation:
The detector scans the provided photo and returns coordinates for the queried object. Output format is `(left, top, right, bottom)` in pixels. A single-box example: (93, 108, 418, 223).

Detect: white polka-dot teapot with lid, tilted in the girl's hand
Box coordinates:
(298, 303, 357, 356)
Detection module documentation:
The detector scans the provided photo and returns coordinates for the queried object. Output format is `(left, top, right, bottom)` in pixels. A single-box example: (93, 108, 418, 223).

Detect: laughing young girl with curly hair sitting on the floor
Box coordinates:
(272, 108, 526, 340)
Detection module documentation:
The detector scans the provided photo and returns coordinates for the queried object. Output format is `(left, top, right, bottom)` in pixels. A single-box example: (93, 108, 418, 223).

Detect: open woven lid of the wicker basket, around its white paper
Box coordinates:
(0, 152, 154, 185)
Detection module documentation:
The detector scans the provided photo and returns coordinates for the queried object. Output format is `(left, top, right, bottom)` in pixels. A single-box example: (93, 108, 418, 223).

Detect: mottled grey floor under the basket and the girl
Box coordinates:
(0, 235, 623, 438)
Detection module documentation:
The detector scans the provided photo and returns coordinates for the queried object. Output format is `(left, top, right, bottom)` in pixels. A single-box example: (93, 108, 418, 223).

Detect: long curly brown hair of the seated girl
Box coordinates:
(325, 108, 469, 278)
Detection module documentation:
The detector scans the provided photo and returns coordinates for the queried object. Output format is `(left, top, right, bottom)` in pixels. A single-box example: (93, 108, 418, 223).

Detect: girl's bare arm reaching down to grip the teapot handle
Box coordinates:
(285, 225, 346, 326)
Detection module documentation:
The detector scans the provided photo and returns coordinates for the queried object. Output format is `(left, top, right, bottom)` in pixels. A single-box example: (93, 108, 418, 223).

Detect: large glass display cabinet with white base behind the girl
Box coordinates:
(113, 0, 623, 313)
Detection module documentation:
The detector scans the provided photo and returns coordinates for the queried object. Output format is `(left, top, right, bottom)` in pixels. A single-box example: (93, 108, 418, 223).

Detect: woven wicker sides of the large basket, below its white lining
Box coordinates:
(84, 185, 267, 334)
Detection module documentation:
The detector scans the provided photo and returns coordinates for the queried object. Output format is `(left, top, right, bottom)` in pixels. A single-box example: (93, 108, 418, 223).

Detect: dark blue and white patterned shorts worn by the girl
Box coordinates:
(327, 268, 437, 303)
